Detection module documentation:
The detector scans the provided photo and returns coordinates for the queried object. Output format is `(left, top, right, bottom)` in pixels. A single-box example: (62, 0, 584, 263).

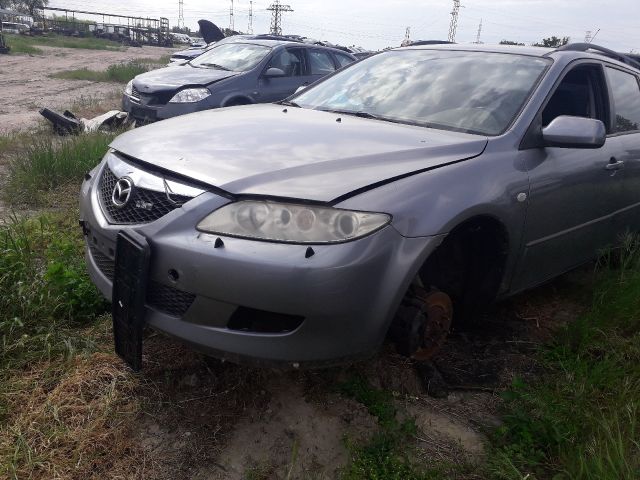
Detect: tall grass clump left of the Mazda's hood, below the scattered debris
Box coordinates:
(3, 132, 115, 206)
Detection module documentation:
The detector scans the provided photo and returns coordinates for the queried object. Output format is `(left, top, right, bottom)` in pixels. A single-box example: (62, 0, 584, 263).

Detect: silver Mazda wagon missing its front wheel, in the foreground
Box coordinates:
(80, 44, 640, 368)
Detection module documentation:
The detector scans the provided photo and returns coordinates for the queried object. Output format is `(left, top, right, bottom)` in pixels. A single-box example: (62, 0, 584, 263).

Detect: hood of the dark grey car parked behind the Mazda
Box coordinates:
(133, 65, 238, 93)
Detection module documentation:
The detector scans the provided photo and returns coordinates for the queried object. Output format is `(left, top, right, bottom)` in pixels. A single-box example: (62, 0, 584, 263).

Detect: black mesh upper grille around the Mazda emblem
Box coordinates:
(99, 166, 191, 225)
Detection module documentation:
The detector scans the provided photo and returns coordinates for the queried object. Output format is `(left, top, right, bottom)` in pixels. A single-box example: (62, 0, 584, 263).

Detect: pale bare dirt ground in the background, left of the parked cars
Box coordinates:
(0, 46, 176, 133)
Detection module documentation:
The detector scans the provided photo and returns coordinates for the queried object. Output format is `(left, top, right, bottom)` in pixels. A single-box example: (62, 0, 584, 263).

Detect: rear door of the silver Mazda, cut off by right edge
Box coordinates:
(605, 65, 640, 235)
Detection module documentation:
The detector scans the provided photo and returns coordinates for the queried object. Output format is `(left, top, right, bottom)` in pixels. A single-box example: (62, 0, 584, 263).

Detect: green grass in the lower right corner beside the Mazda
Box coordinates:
(488, 237, 640, 480)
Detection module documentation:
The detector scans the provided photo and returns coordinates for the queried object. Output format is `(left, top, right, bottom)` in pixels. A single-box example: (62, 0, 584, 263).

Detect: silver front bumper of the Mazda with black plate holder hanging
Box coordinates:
(81, 159, 441, 366)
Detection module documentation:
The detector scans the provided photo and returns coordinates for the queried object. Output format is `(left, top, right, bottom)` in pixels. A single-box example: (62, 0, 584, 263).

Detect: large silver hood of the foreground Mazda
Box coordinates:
(111, 105, 487, 202)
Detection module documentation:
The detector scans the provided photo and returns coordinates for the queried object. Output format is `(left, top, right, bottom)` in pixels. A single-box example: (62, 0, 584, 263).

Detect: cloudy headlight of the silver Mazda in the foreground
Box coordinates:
(197, 200, 391, 243)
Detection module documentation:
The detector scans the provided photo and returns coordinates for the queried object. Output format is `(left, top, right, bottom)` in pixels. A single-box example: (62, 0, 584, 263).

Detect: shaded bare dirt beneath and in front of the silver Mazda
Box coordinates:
(126, 268, 590, 480)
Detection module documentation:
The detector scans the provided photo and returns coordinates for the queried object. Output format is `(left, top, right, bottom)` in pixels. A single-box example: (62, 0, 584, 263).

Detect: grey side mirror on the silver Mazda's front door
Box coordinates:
(542, 115, 607, 149)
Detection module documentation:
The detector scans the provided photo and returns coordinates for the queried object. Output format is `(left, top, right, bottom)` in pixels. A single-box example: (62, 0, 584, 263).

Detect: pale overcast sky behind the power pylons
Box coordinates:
(49, 0, 640, 53)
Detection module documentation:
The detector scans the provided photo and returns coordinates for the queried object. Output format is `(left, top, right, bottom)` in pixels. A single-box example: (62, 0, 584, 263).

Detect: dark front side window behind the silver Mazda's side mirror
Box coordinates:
(542, 66, 606, 127)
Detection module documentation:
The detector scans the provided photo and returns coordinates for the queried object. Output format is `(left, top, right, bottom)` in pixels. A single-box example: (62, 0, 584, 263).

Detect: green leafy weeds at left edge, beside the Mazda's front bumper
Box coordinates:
(0, 215, 106, 369)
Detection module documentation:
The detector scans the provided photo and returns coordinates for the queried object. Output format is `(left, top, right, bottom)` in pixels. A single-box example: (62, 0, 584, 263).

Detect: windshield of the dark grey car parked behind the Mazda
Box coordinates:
(191, 43, 271, 72)
